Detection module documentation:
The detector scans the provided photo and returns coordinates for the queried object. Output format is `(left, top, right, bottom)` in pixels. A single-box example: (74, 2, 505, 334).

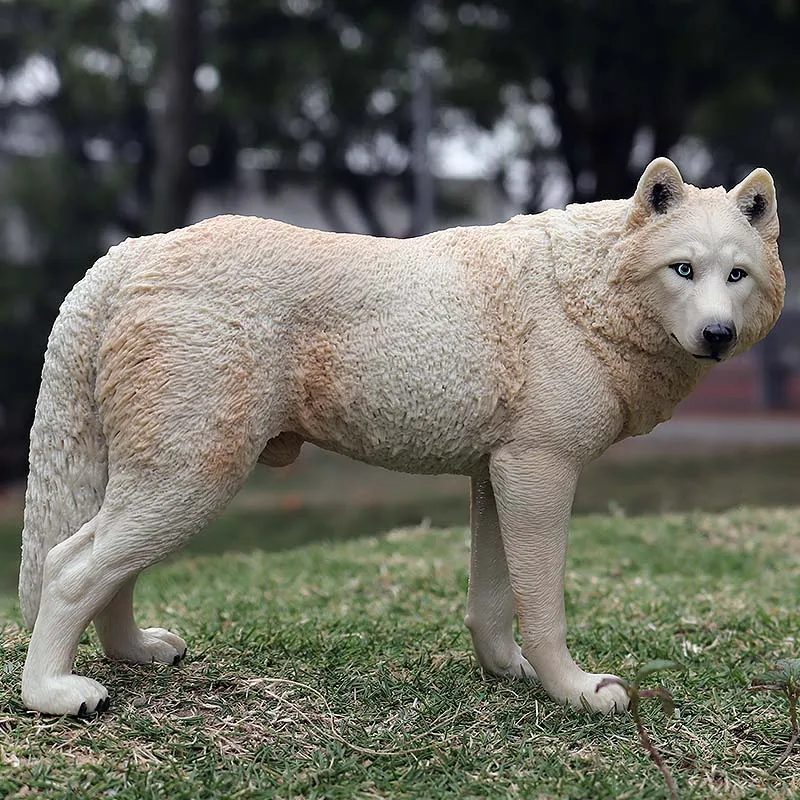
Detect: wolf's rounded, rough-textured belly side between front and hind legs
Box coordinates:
(290, 306, 514, 473)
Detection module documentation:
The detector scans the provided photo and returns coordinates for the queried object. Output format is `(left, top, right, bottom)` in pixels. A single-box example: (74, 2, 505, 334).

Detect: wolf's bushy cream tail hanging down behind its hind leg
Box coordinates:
(19, 257, 114, 628)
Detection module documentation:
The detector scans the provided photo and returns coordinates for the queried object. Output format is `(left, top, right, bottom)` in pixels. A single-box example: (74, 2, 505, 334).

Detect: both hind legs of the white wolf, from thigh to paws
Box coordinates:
(22, 320, 278, 714)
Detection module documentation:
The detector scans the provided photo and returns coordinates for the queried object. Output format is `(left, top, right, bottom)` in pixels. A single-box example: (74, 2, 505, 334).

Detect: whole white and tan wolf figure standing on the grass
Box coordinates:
(15, 159, 784, 714)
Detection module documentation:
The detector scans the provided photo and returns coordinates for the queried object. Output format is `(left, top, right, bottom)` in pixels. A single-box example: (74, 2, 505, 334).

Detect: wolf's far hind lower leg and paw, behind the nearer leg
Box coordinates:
(94, 575, 186, 666)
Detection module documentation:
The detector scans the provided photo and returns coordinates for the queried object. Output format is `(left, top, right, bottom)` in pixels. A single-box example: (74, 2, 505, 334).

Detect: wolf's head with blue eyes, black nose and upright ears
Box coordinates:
(617, 158, 784, 361)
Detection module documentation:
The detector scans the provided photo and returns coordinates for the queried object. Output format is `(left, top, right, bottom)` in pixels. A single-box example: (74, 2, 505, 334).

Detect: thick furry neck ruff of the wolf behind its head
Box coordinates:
(548, 200, 708, 439)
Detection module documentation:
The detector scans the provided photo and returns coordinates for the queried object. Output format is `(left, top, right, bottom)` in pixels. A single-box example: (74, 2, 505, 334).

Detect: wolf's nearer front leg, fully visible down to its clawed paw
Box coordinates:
(490, 445, 628, 712)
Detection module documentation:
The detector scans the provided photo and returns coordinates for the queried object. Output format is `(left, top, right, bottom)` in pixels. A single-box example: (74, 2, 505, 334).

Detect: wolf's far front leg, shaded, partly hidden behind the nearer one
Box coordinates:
(464, 471, 536, 680)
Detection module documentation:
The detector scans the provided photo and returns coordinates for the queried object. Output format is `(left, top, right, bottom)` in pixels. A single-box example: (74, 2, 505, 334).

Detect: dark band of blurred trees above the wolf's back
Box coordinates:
(0, 0, 800, 480)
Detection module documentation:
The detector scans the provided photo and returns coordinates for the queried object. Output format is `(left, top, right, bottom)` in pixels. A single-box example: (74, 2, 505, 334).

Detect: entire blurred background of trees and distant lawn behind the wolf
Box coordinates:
(0, 0, 800, 591)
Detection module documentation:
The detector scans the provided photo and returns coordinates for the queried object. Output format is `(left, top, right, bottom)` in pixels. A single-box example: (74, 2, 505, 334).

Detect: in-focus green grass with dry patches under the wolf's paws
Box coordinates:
(0, 509, 800, 800)
